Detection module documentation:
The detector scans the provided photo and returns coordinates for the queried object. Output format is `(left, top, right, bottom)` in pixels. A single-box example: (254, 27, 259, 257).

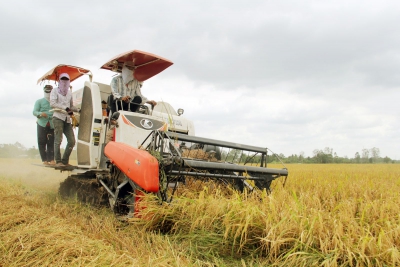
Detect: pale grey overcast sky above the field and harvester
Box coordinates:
(0, 0, 400, 159)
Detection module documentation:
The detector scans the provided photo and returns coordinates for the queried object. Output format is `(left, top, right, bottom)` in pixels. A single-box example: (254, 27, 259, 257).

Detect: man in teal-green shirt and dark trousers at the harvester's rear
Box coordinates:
(33, 84, 55, 165)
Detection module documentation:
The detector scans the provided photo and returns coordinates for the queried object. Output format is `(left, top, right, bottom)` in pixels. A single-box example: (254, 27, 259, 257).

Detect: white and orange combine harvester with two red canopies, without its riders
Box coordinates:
(39, 50, 288, 217)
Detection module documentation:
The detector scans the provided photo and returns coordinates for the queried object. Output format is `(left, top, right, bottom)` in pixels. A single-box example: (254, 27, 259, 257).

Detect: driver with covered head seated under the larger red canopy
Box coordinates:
(110, 63, 157, 113)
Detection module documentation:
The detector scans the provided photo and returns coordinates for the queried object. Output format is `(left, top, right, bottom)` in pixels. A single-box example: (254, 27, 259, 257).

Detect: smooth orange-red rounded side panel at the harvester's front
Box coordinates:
(104, 141, 159, 192)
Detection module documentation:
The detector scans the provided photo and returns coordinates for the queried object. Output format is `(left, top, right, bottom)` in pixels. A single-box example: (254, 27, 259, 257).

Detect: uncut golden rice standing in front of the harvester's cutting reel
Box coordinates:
(138, 165, 400, 266)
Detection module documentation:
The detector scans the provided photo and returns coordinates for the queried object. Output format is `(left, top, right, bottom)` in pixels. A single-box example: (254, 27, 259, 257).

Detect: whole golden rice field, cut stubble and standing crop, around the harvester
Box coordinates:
(0, 159, 400, 266)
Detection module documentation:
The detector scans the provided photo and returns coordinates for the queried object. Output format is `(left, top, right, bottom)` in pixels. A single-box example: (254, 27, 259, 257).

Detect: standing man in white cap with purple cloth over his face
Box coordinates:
(50, 73, 79, 167)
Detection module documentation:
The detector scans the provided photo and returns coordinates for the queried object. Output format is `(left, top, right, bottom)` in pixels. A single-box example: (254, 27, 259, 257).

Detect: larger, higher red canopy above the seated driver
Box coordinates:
(101, 50, 174, 82)
